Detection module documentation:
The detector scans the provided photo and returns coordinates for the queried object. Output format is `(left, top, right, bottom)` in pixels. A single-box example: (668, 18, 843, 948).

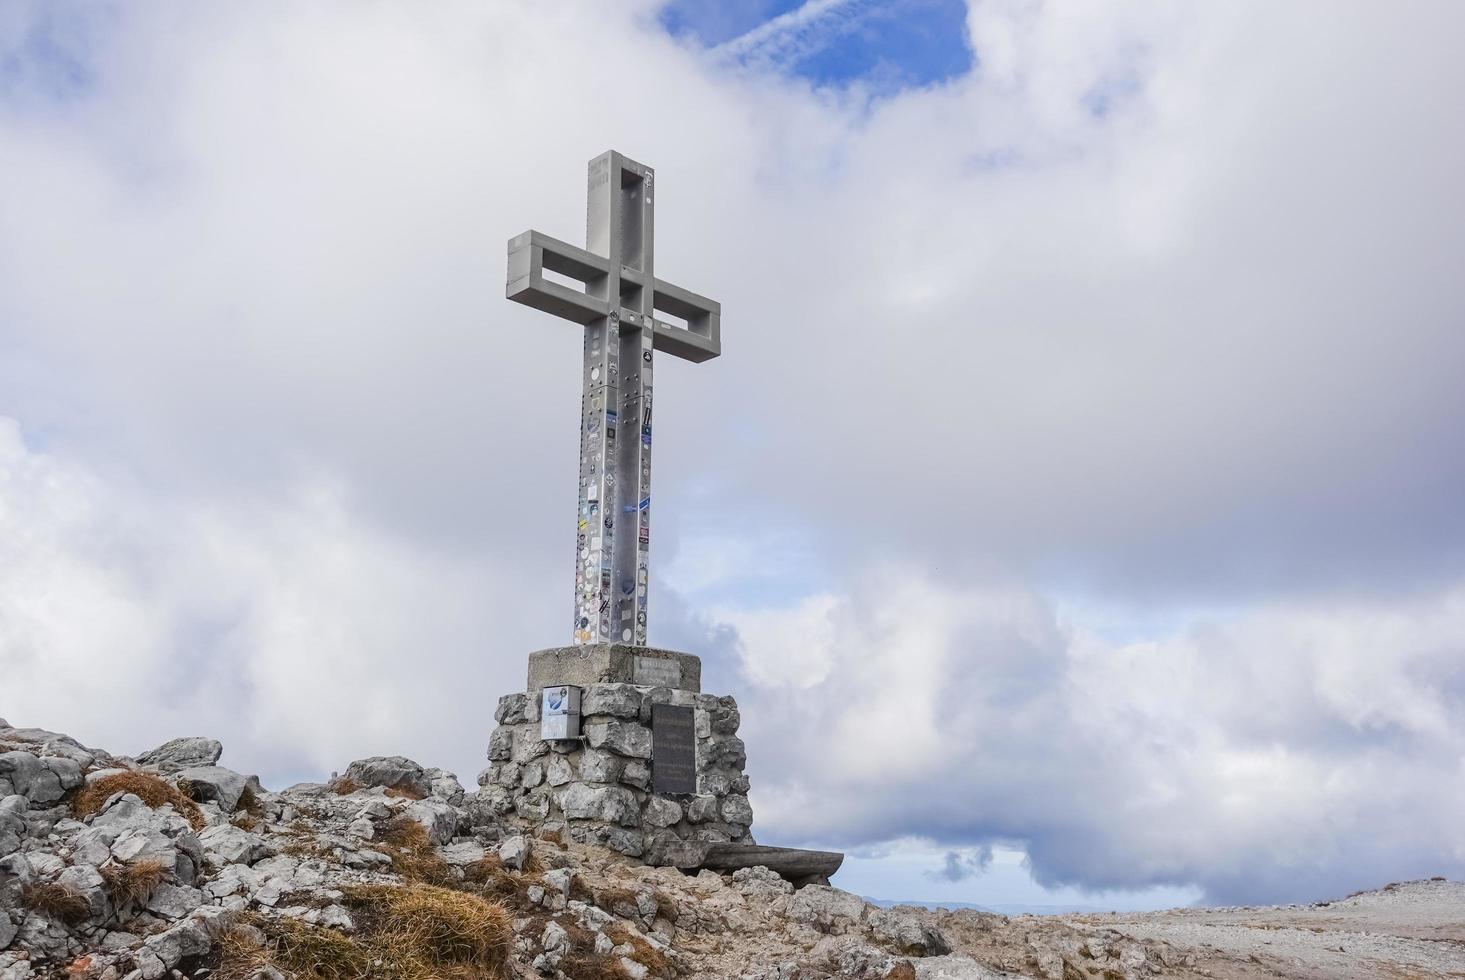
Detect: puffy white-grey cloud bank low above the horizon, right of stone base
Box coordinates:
(731, 570, 1465, 901)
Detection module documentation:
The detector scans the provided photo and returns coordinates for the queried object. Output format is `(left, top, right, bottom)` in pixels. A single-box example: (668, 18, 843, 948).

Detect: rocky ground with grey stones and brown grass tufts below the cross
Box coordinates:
(0, 721, 1465, 980)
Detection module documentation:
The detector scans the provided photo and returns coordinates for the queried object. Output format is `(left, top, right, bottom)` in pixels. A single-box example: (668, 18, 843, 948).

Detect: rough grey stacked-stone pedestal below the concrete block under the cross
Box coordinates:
(478, 684, 753, 863)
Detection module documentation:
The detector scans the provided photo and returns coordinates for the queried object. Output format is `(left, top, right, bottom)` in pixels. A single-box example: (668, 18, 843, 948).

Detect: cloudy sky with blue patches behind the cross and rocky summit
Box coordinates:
(0, 0, 1465, 908)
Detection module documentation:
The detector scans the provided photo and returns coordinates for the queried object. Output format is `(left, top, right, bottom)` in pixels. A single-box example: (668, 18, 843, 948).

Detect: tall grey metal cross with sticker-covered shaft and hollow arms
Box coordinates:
(507, 151, 722, 646)
